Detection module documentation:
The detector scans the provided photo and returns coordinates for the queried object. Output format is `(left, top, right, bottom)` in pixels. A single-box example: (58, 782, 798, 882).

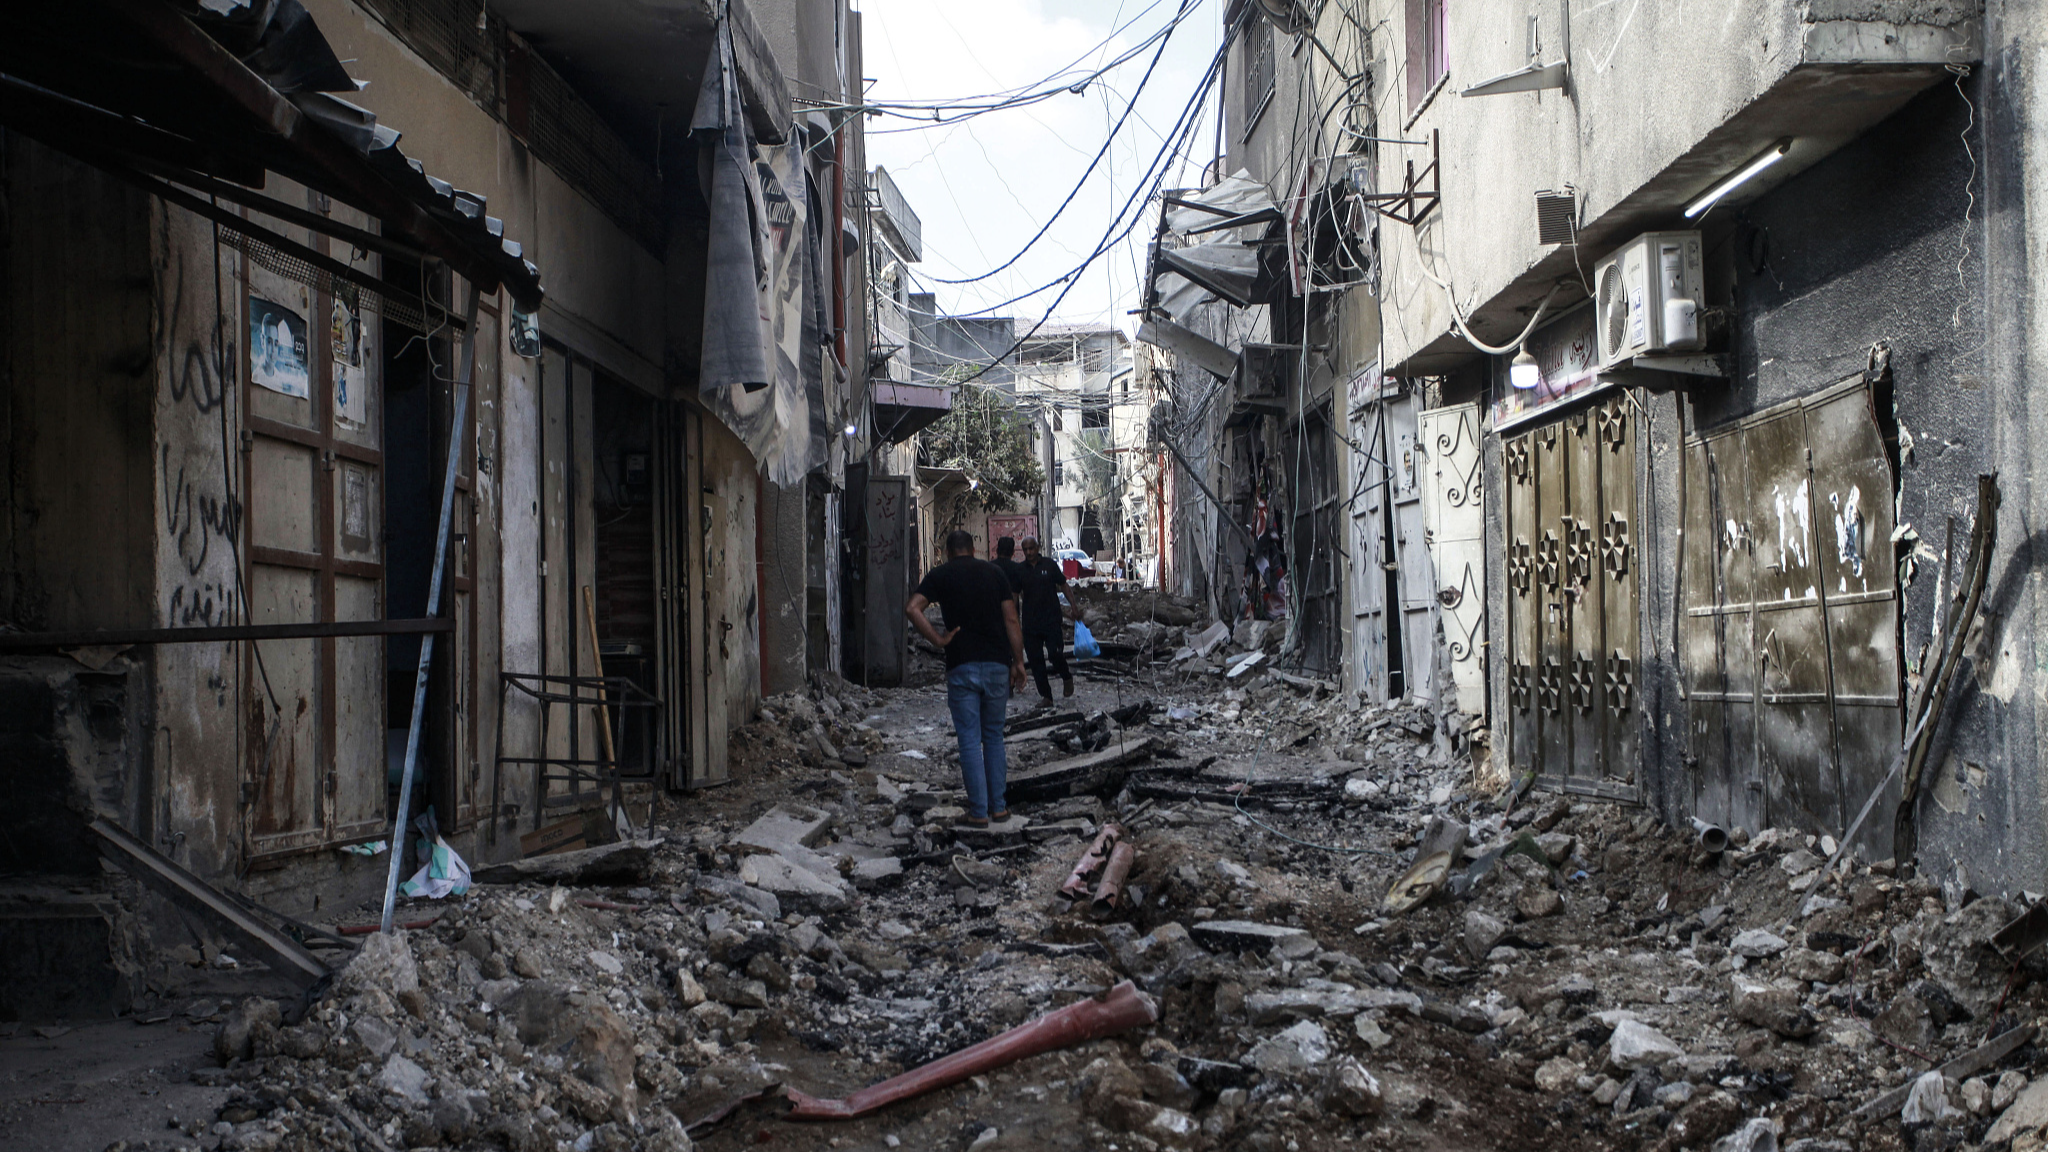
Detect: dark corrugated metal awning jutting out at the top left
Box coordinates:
(0, 0, 543, 310)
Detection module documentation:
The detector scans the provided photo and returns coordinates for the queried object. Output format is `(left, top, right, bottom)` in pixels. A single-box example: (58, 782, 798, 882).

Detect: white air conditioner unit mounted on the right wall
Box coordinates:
(1593, 232, 1704, 369)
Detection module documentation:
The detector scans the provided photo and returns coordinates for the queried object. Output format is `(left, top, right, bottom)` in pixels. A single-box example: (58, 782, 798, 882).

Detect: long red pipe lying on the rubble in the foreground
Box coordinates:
(788, 980, 1159, 1119)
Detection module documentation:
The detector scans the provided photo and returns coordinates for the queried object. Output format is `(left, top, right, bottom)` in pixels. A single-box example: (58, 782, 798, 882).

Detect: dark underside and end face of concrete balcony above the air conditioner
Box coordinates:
(1384, 20, 1982, 377)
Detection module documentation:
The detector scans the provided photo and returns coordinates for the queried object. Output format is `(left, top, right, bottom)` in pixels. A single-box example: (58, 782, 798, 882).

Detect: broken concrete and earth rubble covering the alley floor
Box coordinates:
(133, 676, 2048, 1152)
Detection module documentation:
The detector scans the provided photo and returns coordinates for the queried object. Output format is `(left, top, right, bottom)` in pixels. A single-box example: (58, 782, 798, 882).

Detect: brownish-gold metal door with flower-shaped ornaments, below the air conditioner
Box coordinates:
(1501, 396, 1642, 801)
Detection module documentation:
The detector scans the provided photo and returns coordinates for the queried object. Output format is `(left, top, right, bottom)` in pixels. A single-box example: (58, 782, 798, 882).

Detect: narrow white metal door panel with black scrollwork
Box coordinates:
(1417, 404, 1487, 715)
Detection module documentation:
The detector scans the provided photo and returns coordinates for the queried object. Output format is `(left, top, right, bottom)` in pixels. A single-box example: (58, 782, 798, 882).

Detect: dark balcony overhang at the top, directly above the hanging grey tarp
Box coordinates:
(492, 0, 793, 143)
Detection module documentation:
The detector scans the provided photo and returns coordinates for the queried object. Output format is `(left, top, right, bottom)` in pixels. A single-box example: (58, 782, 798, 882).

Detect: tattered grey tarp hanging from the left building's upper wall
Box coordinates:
(690, 25, 815, 488)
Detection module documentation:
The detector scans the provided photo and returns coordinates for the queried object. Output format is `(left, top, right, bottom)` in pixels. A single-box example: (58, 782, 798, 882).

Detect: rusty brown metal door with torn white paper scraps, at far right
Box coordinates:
(1679, 379, 1901, 851)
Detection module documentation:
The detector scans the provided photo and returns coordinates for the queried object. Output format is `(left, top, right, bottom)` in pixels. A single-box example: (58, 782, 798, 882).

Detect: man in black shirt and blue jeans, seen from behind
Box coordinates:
(903, 529, 1024, 828)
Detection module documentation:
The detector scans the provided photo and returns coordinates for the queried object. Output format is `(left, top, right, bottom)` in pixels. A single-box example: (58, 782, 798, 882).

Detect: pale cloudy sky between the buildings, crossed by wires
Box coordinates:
(860, 0, 1223, 330)
